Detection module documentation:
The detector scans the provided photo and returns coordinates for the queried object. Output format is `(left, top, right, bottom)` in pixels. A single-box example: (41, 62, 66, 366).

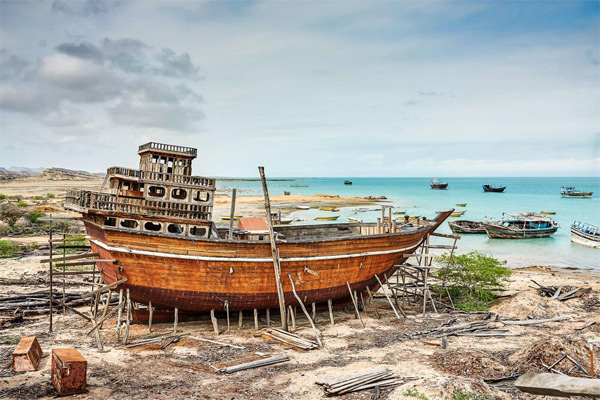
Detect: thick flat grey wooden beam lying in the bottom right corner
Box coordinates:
(515, 372, 600, 397)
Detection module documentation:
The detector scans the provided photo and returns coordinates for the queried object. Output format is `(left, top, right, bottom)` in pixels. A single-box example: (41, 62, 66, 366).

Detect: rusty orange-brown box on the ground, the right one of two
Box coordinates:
(52, 349, 87, 396)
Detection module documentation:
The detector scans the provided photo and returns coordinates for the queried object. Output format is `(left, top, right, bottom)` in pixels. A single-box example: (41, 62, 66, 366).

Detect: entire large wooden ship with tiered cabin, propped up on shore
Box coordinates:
(65, 142, 451, 311)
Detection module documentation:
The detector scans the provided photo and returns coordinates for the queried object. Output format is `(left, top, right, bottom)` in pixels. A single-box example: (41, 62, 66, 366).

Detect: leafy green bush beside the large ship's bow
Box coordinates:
(437, 251, 512, 311)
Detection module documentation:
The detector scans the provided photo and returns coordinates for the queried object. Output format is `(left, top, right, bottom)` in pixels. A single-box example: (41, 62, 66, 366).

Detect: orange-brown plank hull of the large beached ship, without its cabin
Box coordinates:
(84, 212, 449, 311)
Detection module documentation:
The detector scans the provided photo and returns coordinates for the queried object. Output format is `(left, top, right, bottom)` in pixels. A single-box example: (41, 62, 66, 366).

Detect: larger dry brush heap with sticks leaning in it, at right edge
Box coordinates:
(509, 336, 599, 376)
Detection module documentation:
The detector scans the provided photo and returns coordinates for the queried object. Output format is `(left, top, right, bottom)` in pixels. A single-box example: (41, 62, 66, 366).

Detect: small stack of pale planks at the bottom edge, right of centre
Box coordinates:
(315, 367, 414, 396)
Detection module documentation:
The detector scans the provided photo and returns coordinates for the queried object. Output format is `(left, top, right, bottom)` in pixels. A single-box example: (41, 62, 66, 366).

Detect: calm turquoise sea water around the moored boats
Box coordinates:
(217, 177, 600, 269)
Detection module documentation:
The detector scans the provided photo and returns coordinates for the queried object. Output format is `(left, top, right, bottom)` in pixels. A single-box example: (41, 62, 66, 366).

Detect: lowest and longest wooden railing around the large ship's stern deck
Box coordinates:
(65, 190, 212, 220)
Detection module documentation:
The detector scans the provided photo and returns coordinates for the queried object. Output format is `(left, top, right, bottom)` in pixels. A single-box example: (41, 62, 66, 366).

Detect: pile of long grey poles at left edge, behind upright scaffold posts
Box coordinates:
(0, 290, 95, 315)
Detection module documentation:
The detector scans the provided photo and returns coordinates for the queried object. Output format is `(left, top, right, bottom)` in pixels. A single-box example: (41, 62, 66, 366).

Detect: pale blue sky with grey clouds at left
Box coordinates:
(0, 0, 600, 177)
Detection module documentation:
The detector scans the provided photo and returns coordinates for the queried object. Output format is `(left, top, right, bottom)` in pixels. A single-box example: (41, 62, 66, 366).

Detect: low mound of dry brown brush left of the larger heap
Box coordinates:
(433, 350, 510, 378)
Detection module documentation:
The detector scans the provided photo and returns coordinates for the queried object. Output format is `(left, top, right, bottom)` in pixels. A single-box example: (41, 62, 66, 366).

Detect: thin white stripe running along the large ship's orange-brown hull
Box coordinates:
(90, 240, 418, 262)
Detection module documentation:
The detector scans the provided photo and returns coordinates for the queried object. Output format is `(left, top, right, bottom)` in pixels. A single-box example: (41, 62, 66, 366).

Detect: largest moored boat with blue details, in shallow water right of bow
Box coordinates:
(483, 213, 559, 239)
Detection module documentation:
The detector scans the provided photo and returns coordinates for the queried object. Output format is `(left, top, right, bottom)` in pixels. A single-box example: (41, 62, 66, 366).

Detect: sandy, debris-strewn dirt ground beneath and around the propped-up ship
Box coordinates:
(0, 255, 600, 399)
